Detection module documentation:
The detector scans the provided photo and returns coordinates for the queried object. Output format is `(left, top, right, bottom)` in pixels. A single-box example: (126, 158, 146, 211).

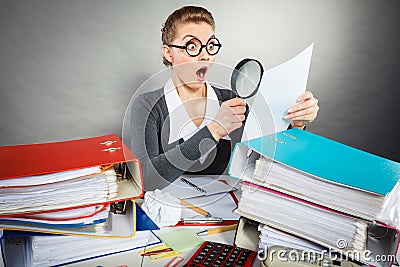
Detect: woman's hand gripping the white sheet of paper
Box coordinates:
(285, 91, 319, 129)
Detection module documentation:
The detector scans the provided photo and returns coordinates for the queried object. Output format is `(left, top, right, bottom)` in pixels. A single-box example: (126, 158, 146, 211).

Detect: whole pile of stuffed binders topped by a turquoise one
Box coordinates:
(229, 129, 400, 266)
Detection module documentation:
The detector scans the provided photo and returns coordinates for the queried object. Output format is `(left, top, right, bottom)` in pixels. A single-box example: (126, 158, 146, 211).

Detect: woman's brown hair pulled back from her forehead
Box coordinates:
(161, 6, 215, 67)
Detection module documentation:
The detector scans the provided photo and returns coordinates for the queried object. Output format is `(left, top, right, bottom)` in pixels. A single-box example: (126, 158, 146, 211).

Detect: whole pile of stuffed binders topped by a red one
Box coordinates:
(0, 135, 160, 266)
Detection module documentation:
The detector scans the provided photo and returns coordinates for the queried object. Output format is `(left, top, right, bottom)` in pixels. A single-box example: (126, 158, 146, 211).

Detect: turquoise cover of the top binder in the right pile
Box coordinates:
(228, 129, 400, 195)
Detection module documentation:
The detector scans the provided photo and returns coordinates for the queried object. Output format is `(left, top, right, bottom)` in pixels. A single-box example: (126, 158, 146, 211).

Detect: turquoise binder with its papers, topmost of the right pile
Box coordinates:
(229, 129, 400, 227)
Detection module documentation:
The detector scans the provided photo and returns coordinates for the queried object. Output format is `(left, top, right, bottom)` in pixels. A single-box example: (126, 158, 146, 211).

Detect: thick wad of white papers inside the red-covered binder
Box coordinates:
(0, 167, 118, 215)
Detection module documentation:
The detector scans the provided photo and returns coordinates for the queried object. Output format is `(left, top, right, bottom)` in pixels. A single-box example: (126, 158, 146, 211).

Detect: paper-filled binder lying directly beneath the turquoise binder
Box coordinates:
(238, 182, 399, 266)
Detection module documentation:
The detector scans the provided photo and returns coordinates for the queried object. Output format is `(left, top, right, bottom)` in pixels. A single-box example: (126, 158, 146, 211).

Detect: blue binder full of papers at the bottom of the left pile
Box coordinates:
(2, 205, 161, 266)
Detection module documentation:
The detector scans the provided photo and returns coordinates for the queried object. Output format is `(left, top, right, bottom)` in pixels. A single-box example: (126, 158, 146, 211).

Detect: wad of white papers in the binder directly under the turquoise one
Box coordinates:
(239, 182, 368, 251)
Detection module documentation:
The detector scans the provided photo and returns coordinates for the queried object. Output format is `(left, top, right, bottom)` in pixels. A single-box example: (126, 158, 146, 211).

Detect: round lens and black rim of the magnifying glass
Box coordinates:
(231, 58, 264, 99)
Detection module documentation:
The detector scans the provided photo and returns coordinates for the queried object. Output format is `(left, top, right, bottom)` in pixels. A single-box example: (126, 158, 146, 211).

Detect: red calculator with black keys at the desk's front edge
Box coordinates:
(184, 241, 256, 267)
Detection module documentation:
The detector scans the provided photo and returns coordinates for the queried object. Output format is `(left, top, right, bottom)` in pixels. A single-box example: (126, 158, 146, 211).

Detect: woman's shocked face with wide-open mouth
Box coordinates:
(163, 22, 215, 89)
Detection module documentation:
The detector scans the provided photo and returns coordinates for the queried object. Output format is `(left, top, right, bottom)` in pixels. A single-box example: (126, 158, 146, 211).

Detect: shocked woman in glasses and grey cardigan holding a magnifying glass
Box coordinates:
(131, 6, 319, 190)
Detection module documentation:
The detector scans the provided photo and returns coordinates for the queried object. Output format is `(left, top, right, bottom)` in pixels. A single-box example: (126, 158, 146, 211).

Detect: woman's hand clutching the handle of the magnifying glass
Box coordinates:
(207, 97, 246, 141)
